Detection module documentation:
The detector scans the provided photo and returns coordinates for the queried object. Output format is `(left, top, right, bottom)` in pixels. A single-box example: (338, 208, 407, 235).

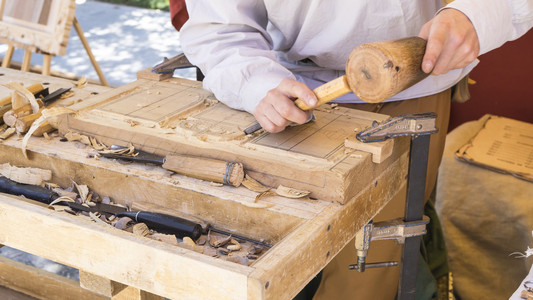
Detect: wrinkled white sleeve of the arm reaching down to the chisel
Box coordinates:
(180, 0, 295, 113)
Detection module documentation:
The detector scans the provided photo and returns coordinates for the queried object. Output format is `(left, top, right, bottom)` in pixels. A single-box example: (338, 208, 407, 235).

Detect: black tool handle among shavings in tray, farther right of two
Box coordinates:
(117, 211, 202, 240)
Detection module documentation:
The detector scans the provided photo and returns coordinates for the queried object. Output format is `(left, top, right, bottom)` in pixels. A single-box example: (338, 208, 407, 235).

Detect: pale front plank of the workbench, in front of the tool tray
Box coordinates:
(0, 194, 251, 299)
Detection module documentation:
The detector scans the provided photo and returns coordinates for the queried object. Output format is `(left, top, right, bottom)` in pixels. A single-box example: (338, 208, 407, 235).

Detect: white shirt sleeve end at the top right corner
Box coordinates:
(446, 0, 533, 55)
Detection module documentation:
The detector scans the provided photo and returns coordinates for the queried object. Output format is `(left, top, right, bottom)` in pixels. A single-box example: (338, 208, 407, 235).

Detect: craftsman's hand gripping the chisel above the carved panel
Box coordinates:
(254, 79, 317, 133)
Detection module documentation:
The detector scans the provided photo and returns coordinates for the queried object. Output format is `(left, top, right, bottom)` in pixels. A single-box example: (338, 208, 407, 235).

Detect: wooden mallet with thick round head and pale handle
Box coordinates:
(244, 37, 429, 134)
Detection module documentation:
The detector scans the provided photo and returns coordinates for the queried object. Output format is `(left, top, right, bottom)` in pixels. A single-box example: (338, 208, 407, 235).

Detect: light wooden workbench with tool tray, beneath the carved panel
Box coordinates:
(0, 69, 408, 299)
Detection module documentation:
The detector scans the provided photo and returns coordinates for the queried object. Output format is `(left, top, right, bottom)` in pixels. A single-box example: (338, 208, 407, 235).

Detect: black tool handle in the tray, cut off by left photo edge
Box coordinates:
(0, 176, 59, 204)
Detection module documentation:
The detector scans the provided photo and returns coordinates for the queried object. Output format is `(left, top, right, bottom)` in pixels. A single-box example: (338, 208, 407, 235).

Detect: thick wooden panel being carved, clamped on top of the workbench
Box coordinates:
(59, 78, 392, 203)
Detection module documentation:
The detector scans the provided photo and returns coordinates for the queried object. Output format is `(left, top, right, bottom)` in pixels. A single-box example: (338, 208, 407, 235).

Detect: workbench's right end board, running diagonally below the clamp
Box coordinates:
(250, 153, 408, 299)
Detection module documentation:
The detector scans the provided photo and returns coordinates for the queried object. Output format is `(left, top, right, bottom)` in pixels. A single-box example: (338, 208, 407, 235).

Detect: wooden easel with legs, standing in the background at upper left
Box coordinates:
(0, 0, 109, 86)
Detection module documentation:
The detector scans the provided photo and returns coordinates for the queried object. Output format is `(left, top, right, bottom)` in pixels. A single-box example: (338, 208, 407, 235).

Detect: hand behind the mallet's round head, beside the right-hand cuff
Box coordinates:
(418, 8, 479, 75)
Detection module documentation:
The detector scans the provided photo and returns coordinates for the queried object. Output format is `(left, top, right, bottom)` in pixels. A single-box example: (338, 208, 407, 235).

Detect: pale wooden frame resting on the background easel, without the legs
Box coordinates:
(0, 0, 76, 55)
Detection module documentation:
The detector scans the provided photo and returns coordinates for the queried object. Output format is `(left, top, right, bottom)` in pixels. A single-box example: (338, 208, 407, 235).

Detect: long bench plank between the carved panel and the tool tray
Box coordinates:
(0, 134, 308, 243)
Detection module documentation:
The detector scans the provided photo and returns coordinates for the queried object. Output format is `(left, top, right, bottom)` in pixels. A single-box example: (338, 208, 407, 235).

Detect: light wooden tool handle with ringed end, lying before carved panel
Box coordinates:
(163, 154, 244, 187)
